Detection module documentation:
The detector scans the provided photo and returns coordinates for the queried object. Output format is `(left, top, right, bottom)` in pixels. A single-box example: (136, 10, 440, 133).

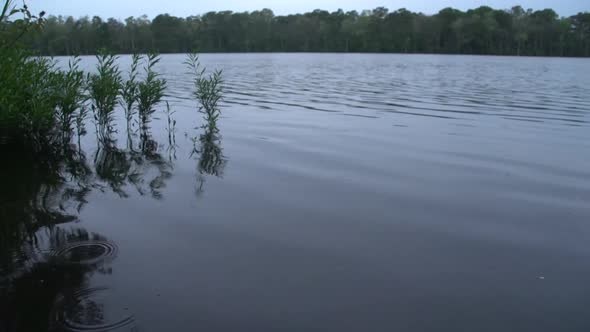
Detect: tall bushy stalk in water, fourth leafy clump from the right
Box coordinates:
(88, 51, 123, 142)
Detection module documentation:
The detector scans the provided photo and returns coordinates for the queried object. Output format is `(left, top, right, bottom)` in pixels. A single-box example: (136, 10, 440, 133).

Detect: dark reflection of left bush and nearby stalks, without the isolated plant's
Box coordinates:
(0, 136, 172, 331)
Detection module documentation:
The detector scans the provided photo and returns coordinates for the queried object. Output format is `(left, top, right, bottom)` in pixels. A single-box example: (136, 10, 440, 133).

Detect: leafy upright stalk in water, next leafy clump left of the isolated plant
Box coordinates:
(137, 53, 167, 131)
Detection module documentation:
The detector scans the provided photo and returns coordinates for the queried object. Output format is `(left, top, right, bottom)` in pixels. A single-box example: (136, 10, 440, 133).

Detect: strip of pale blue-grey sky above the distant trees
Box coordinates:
(28, 0, 590, 19)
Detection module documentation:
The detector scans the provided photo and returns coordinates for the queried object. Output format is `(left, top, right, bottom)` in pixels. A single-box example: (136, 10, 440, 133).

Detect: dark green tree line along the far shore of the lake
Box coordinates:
(12, 6, 590, 57)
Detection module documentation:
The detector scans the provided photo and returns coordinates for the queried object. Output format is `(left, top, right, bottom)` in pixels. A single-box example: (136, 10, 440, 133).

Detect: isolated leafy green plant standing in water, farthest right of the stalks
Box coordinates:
(184, 53, 223, 132)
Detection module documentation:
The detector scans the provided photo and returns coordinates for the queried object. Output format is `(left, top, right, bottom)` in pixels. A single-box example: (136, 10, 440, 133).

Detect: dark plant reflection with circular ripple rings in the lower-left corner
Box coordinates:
(0, 226, 133, 331)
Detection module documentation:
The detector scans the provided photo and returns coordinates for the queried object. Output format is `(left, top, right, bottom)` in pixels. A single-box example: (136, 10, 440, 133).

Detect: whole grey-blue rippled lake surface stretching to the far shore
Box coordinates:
(0, 54, 590, 332)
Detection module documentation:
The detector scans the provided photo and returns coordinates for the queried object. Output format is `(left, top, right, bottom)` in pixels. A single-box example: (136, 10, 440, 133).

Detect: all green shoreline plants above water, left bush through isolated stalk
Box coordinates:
(0, 0, 222, 154)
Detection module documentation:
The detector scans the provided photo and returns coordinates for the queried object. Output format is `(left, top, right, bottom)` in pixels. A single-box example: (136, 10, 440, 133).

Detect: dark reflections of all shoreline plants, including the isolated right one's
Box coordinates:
(0, 108, 227, 332)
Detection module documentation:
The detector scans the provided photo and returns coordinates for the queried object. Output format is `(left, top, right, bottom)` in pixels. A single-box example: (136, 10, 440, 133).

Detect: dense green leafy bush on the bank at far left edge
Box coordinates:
(0, 0, 51, 150)
